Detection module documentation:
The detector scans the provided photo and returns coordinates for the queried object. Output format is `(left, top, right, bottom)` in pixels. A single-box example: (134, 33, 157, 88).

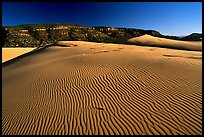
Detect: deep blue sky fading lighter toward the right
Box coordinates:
(2, 2, 202, 36)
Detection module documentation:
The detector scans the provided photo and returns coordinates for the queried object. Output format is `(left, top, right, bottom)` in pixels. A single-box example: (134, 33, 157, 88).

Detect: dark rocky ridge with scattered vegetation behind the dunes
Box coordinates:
(1, 23, 202, 47)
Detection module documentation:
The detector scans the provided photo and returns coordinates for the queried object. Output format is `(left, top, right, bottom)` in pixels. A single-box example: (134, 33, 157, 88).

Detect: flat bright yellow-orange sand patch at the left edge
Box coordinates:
(2, 48, 35, 63)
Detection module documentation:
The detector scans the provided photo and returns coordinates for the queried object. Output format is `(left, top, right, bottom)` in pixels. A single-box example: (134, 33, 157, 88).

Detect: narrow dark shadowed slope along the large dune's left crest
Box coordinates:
(2, 43, 68, 67)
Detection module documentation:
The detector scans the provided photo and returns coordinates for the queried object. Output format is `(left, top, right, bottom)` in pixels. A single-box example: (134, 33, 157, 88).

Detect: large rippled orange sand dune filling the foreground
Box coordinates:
(2, 41, 202, 135)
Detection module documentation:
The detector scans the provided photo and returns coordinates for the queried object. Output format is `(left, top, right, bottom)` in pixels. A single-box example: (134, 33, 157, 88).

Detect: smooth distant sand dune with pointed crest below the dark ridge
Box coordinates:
(127, 34, 202, 51)
